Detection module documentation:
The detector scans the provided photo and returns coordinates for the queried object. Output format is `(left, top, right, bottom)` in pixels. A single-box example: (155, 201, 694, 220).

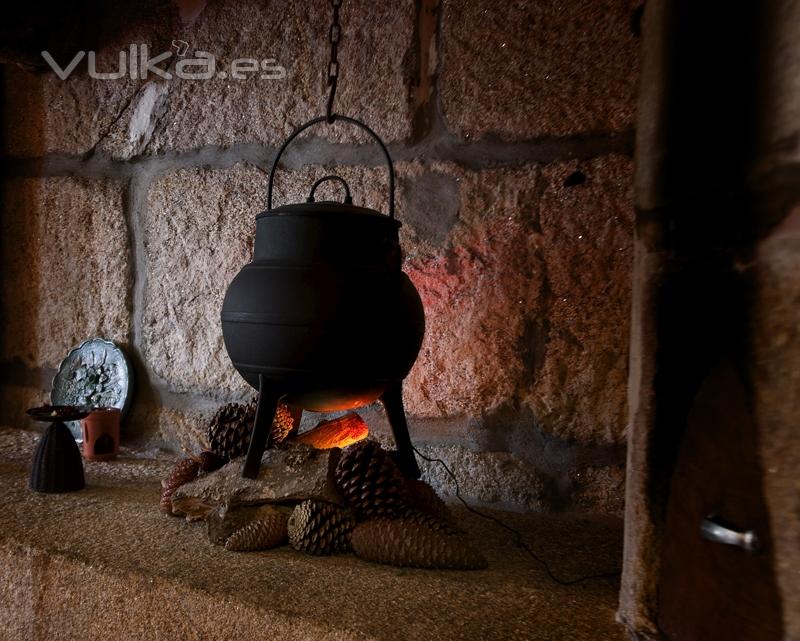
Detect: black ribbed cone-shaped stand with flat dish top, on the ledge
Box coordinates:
(28, 406, 88, 493)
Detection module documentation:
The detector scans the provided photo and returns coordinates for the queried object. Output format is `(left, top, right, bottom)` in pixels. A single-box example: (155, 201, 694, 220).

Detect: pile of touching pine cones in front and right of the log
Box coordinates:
(217, 441, 486, 570)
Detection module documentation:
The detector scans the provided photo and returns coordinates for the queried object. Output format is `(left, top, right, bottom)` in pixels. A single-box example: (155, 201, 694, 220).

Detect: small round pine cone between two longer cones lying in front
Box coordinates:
(289, 500, 355, 554)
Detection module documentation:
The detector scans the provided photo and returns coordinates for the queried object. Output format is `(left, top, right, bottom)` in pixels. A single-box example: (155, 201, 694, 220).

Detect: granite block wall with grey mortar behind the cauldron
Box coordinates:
(0, 0, 640, 513)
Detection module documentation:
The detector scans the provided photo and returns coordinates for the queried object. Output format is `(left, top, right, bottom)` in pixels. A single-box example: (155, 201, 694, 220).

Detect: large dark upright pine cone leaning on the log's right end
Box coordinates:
(335, 441, 410, 520)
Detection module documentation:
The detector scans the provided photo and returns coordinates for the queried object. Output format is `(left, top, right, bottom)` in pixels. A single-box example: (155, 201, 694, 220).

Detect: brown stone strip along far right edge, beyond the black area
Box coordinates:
(752, 0, 800, 641)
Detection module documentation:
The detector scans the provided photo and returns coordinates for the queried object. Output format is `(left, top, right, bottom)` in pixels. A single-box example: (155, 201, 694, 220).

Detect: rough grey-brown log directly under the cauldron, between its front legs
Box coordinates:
(172, 445, 341, 516)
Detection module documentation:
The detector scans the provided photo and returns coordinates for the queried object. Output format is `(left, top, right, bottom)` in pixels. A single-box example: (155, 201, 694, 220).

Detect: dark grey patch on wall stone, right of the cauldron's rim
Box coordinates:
(401, 172, 460, 248)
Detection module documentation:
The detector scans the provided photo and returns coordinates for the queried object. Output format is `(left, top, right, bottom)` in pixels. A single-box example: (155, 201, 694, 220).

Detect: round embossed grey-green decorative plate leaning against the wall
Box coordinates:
(50, 338, 133, 443)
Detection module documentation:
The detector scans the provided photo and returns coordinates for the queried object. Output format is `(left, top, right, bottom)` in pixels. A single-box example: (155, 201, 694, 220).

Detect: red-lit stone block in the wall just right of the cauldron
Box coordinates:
(404, 166, 542, 417)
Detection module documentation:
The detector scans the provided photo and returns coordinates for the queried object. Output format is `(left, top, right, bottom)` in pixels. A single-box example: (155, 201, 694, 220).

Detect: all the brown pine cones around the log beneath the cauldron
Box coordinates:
(161, 402, 486, 569)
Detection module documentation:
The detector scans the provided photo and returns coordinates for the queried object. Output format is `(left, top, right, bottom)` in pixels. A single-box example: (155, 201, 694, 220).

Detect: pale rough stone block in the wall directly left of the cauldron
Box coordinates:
(142, 166, 265, 395)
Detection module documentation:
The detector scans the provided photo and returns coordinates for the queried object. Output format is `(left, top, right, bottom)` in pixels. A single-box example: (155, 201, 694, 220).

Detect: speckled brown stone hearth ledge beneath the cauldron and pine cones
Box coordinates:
(0, 429, 626, 641)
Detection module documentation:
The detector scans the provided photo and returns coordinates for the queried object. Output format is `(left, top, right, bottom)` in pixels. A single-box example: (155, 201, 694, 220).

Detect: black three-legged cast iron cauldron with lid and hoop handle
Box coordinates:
(222, 115, 425, 478)
